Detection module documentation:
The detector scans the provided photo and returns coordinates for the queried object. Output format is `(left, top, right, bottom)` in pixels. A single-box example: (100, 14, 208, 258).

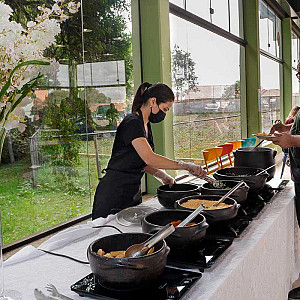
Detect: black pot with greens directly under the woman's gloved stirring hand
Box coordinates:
(201, 180, 250, 203)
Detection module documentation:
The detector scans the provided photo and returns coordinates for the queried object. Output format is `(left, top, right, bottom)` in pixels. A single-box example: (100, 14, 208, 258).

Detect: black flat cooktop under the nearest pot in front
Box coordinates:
(71, 266, 202, 300)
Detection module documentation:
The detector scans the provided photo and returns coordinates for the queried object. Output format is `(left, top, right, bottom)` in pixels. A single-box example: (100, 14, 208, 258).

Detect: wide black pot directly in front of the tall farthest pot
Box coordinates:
(213, 167, 269, 192)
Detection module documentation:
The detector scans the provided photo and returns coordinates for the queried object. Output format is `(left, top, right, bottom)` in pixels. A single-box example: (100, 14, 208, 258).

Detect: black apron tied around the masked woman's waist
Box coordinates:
(92, 110, 153, 220)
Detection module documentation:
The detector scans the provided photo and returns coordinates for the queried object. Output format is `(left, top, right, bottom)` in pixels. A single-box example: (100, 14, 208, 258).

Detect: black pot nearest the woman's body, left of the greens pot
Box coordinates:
(157, 183, 200, 208)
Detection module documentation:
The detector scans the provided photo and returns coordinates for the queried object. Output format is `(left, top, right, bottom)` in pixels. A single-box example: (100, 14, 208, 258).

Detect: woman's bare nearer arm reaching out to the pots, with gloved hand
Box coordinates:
(132, 137, 206, 177)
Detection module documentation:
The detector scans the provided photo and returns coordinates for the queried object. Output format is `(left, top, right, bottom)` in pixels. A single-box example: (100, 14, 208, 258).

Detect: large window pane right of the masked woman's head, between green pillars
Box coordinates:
(170, 8, 241, 159)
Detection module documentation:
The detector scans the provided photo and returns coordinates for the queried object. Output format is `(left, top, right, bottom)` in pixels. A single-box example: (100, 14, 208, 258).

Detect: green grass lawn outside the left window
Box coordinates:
(0, 157, 108, 244)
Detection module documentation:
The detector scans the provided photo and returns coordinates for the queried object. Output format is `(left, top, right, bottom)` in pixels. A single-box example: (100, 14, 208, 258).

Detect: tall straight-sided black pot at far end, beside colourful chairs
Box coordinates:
(233, 147, 277, 181)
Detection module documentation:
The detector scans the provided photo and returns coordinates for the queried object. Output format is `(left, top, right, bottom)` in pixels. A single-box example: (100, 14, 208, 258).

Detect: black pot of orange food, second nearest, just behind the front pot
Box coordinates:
(142, 209, 208, 253)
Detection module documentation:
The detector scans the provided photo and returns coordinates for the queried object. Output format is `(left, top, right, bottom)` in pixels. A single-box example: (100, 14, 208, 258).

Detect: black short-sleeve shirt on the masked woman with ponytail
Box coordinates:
(107, 113, 154, 173)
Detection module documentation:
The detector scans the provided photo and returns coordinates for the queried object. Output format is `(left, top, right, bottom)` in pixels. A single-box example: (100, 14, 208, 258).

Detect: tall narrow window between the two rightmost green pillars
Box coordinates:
(259, 1, 282, 132)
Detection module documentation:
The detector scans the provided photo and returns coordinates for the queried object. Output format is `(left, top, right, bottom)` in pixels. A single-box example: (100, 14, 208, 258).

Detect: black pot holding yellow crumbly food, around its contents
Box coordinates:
(175, 195, 241, 224)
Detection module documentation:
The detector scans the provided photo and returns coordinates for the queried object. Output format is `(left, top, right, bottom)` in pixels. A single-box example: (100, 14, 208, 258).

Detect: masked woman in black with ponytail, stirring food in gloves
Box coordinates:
(92, 82, 206, 220)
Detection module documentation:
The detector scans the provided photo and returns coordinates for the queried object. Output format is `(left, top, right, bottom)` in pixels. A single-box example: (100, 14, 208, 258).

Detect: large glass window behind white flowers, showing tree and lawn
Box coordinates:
(0, 0, 133, 243)
